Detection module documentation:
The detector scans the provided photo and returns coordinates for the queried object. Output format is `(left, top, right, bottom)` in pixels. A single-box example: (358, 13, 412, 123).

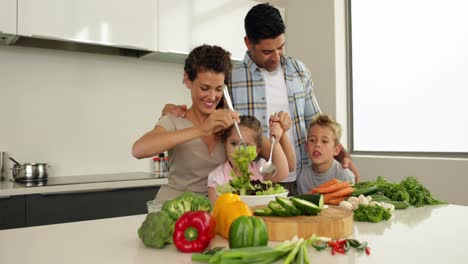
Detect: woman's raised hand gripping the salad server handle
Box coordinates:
(201, 109, 239, 135)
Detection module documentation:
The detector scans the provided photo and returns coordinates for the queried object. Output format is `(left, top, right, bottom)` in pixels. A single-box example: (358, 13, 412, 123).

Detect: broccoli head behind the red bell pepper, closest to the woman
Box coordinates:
(162, 192, 212, 221)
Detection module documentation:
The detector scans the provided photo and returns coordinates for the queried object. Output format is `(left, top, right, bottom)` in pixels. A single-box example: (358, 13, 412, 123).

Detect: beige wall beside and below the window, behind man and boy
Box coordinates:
(286, 0, 468, 205)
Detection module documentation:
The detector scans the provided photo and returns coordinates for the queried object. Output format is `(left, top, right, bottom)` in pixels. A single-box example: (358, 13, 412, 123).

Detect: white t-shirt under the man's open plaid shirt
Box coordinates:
(260, 67, 297, 182)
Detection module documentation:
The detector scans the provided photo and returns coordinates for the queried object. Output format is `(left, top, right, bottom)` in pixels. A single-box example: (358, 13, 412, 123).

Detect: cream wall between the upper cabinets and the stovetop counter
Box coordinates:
(0, 46, 190, 176)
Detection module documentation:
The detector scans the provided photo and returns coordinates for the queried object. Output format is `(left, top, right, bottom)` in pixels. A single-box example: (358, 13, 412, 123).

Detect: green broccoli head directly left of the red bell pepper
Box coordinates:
(138, 211, 175, 248)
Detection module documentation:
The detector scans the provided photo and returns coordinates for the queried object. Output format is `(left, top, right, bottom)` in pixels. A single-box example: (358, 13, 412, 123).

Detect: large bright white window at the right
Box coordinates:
(346, 0, 468, 157)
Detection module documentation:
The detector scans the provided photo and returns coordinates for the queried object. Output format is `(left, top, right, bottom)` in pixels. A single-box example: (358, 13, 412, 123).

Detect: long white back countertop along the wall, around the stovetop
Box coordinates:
(0, 173, 167, 198)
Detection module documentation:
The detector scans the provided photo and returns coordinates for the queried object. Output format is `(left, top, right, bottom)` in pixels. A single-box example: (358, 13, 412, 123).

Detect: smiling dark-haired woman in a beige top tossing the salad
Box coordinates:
(132, 45, 239, 201)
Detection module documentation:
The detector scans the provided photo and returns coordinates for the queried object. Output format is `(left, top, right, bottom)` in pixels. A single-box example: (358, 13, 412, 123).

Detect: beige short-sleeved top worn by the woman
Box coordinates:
(156, 115, 226, 200)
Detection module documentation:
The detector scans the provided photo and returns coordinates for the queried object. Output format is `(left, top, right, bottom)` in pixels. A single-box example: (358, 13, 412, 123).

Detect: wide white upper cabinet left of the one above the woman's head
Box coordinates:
(17, 0, 158, 51)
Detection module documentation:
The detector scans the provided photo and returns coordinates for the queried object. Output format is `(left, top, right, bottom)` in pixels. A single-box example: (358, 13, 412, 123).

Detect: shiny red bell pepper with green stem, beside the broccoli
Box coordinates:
(173, 211, 216, 252)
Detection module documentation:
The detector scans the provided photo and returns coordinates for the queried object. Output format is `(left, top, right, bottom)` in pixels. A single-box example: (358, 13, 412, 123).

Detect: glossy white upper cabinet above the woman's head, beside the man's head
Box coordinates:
(159, 0, 258, 60)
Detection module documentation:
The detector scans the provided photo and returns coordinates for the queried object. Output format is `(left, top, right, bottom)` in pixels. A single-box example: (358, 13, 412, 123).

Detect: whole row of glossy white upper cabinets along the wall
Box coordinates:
(0, 0, 284, 61)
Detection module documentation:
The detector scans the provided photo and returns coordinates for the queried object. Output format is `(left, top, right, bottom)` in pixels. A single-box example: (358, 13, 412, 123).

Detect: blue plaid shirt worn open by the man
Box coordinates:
(230, 53, 320, 177)
